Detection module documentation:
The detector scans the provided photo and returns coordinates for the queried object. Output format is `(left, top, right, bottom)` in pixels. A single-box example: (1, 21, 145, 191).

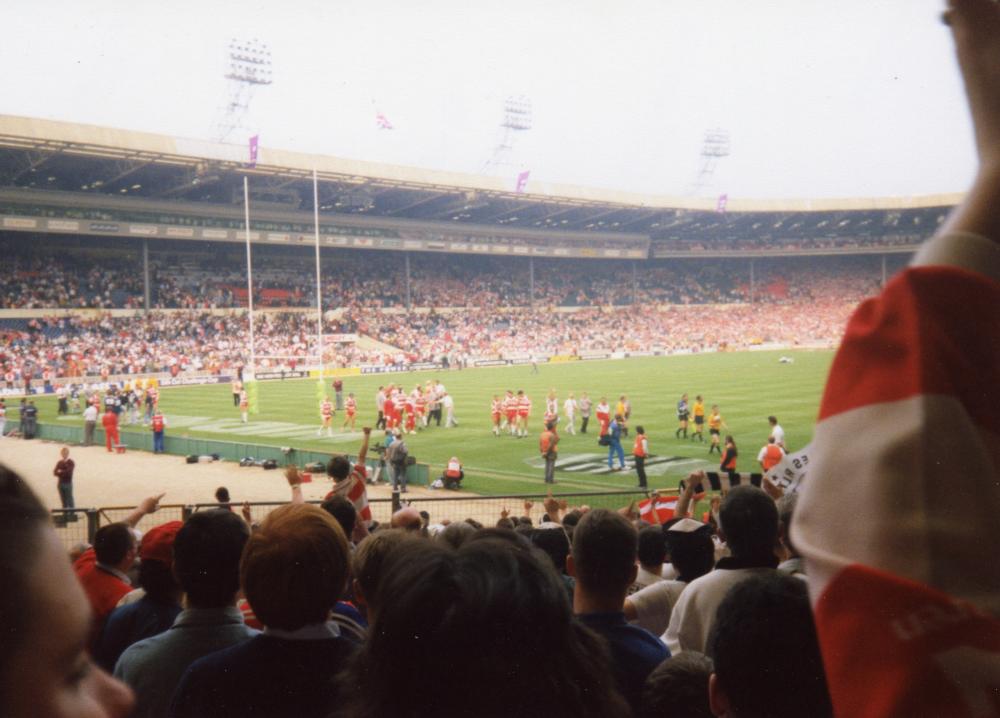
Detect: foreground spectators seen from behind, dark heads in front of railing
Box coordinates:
(0, 458, 832, 718)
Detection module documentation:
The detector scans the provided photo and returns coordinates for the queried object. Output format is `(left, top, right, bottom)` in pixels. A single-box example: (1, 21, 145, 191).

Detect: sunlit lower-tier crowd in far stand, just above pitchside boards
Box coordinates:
(0, 299, 854, 388)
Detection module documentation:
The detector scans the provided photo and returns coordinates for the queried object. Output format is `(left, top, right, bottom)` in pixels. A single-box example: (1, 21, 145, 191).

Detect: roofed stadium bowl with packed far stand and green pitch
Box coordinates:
(0, 117, 957, 502)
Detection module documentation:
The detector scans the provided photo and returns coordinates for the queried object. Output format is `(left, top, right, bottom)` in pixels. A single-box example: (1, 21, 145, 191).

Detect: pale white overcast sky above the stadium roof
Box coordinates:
(0, 0, 974, 198)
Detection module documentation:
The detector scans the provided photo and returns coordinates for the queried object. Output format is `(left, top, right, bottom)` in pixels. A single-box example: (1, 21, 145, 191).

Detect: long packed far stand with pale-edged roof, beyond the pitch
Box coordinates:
(0, 116, 956, 384)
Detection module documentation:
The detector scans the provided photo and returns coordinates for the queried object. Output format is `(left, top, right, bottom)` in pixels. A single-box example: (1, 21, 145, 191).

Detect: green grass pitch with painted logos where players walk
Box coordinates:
(39, 351, 833, 495)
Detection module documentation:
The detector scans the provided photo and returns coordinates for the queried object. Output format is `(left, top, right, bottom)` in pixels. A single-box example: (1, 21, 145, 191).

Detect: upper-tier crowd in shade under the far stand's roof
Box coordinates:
(0, 239, 901, 310)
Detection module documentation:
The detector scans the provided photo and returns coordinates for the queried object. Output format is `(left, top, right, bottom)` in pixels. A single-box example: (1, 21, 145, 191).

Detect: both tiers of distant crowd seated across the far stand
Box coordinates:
(0, 243, 901, 386)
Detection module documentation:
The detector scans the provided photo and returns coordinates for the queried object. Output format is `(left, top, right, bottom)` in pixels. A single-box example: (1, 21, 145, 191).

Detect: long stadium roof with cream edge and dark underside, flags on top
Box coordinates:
(0, 115, 960, 238)
